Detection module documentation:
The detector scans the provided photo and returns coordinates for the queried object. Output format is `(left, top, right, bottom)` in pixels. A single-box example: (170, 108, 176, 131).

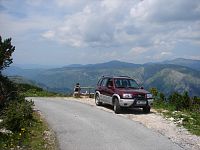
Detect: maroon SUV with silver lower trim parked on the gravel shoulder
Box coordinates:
(95, 76, 153, 113)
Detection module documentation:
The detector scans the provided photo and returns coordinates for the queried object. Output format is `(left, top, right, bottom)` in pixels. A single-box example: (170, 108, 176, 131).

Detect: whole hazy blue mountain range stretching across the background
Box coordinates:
(4, 60, 200, 96)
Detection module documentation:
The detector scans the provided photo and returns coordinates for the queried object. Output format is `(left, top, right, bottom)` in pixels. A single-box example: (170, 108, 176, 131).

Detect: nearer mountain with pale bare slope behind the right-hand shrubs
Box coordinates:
(144, 66, 200, 96)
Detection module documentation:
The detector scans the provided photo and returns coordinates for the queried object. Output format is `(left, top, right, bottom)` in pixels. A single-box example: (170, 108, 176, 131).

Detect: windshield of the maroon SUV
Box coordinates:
(115, 79, 139, 89)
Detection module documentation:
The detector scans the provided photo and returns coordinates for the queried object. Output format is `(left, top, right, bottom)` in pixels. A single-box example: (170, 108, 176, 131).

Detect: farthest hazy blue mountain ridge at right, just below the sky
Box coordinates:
(162, 58, 200, 71)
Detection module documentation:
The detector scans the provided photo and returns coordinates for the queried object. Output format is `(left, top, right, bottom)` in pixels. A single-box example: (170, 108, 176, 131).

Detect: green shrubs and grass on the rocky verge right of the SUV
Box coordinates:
(150, 88, 200, 136)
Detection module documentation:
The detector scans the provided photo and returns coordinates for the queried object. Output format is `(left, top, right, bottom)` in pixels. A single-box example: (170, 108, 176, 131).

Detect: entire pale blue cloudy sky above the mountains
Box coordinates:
(0, 0, 200, 66)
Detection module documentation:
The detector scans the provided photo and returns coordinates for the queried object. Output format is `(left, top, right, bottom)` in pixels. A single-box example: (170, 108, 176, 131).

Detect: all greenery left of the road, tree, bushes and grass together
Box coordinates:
(0, 36, 57, 150)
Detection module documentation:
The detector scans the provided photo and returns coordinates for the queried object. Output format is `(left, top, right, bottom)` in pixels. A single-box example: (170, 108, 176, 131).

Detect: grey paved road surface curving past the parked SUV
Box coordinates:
(31, 98, 181, 150)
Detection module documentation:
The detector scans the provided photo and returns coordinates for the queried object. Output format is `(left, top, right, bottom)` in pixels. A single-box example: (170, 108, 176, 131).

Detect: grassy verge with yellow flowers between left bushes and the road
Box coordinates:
(0, 112, 58, 150)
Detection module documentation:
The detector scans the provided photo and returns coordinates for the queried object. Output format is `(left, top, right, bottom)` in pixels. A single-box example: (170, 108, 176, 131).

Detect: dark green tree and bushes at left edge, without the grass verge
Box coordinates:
(0, 36, 38, 149)
